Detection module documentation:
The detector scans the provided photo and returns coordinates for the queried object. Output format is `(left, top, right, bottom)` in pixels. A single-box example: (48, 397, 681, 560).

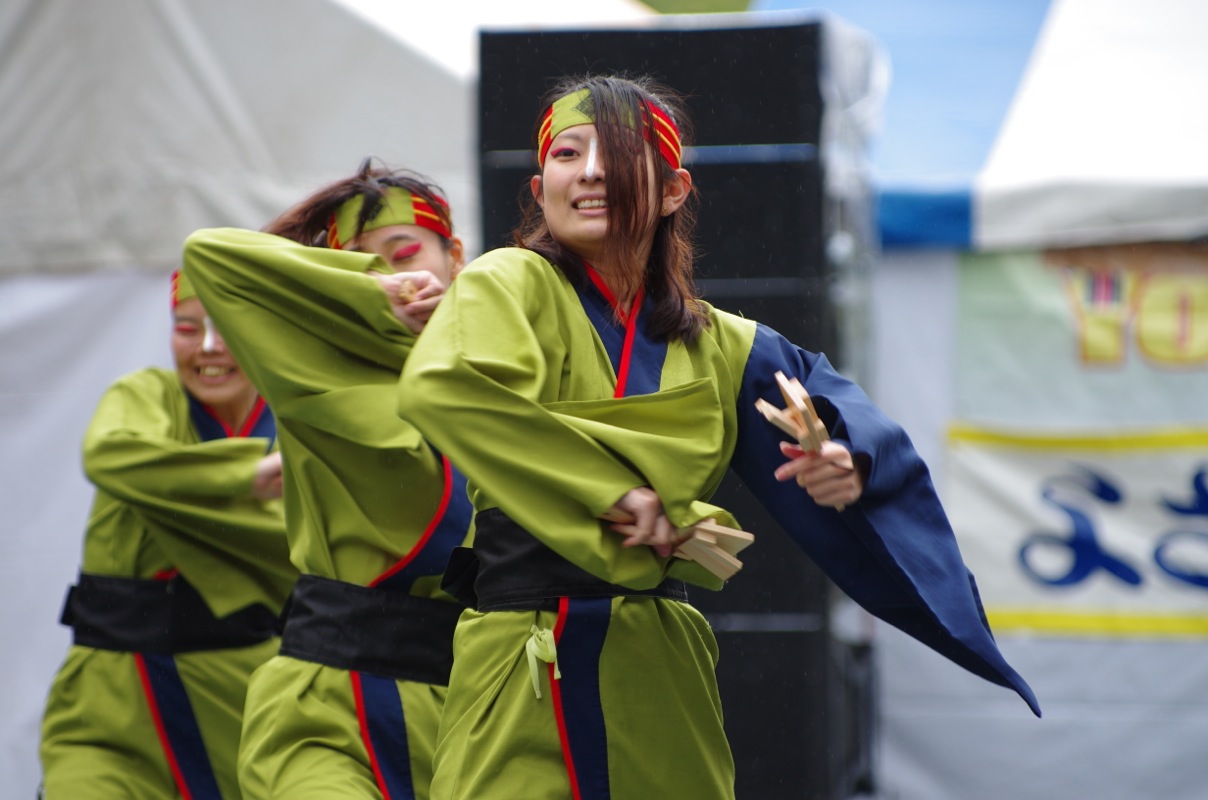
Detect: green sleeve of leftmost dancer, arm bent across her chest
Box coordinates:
(83, 370, 296, 616)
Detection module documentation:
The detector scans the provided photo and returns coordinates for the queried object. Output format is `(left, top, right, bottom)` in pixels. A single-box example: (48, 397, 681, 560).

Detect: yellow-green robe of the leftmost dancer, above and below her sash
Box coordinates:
(41, 367, 296, 800)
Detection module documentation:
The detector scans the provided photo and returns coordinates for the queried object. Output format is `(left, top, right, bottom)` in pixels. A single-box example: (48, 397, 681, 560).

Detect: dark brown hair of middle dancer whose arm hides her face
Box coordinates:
(263, 156, 453, 250)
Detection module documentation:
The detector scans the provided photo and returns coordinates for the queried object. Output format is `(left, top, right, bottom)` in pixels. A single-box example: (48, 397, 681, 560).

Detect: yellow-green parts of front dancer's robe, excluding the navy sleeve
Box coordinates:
(401, 249, 753, 800)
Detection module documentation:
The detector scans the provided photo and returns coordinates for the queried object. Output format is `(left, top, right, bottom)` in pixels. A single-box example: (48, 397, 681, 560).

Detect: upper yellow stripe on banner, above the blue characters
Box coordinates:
(948, 422, 1208, 452)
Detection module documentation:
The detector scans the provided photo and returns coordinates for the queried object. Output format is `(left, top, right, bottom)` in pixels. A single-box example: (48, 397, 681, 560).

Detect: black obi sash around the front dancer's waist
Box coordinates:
(441, 509, 687, 611)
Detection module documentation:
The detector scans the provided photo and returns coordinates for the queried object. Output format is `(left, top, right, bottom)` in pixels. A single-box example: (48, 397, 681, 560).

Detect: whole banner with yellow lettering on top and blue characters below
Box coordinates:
(947, 244, 1208, 637)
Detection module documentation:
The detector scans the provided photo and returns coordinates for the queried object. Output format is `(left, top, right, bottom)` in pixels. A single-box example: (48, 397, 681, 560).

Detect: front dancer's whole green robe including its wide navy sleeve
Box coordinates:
(399, 248, 1035, 800)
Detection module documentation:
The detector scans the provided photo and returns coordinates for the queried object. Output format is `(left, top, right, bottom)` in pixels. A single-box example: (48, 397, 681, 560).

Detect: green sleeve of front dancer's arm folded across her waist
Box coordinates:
(399, 249, 666, 589)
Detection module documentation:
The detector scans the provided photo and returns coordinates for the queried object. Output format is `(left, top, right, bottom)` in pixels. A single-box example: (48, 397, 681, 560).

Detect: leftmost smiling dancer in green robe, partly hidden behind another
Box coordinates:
(41, 274, 297, 800)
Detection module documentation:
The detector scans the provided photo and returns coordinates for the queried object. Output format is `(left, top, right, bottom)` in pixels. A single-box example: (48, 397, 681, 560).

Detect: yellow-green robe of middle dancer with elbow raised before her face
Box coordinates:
(184, 228, 470, 799)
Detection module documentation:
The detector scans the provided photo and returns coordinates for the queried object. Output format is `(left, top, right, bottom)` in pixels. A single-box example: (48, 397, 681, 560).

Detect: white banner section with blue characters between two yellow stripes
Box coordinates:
(948, 428, 1208, 636)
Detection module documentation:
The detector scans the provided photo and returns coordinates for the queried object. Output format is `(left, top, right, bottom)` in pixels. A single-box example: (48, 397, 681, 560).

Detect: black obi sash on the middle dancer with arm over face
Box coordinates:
(280, 575, 464, 686)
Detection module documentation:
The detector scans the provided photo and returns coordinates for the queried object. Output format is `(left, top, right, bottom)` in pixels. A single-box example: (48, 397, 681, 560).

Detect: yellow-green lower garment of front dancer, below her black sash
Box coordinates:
(432, 597, 734, 800)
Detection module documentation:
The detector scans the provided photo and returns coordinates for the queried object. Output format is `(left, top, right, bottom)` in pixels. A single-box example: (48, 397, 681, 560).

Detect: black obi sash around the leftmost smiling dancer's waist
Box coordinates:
(59, 573, 277, 654)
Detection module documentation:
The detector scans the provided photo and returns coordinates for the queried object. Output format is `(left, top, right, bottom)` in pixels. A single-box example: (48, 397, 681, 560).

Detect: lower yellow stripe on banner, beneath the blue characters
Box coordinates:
(986, 608, 1208, 639)
